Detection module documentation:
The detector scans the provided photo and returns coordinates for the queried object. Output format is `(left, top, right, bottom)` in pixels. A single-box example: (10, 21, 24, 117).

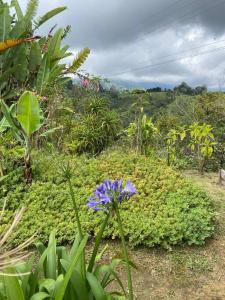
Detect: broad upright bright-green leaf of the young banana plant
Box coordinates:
(17, 92, 41, 138)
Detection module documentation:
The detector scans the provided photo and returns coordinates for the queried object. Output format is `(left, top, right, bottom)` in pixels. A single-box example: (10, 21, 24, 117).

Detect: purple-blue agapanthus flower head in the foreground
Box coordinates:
(87, 180, 137, 210)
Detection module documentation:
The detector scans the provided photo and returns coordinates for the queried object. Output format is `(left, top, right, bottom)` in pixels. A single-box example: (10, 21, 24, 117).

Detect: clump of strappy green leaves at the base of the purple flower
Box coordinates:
(0, 231, 125, 300)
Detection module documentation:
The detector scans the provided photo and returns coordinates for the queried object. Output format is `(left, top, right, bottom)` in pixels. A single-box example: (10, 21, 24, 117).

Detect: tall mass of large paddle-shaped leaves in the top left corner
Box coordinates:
(0, 0, 90, 100)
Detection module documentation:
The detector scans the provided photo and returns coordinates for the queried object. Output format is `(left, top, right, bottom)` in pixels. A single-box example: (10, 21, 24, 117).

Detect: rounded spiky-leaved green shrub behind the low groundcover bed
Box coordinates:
(65, 97, 121, 155)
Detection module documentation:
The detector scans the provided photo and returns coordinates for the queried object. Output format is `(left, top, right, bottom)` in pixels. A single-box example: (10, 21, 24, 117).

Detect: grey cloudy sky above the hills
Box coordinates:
(19, 0, 225, 89)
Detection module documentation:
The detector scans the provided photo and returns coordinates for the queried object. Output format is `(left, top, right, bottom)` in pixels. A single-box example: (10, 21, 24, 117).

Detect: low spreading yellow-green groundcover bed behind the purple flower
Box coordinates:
(3, 151, 214, 248)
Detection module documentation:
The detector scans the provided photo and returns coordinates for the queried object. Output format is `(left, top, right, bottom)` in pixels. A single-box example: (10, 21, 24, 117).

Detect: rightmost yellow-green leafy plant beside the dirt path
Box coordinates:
(189, 123, 217, 173)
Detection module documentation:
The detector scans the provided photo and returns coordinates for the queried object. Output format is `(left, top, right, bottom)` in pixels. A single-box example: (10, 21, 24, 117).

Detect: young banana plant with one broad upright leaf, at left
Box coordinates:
(0, 91, 43, 183)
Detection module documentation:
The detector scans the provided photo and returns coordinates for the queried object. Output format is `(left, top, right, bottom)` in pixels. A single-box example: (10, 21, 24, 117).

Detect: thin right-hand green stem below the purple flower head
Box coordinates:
(115, 203, 134, 300)
